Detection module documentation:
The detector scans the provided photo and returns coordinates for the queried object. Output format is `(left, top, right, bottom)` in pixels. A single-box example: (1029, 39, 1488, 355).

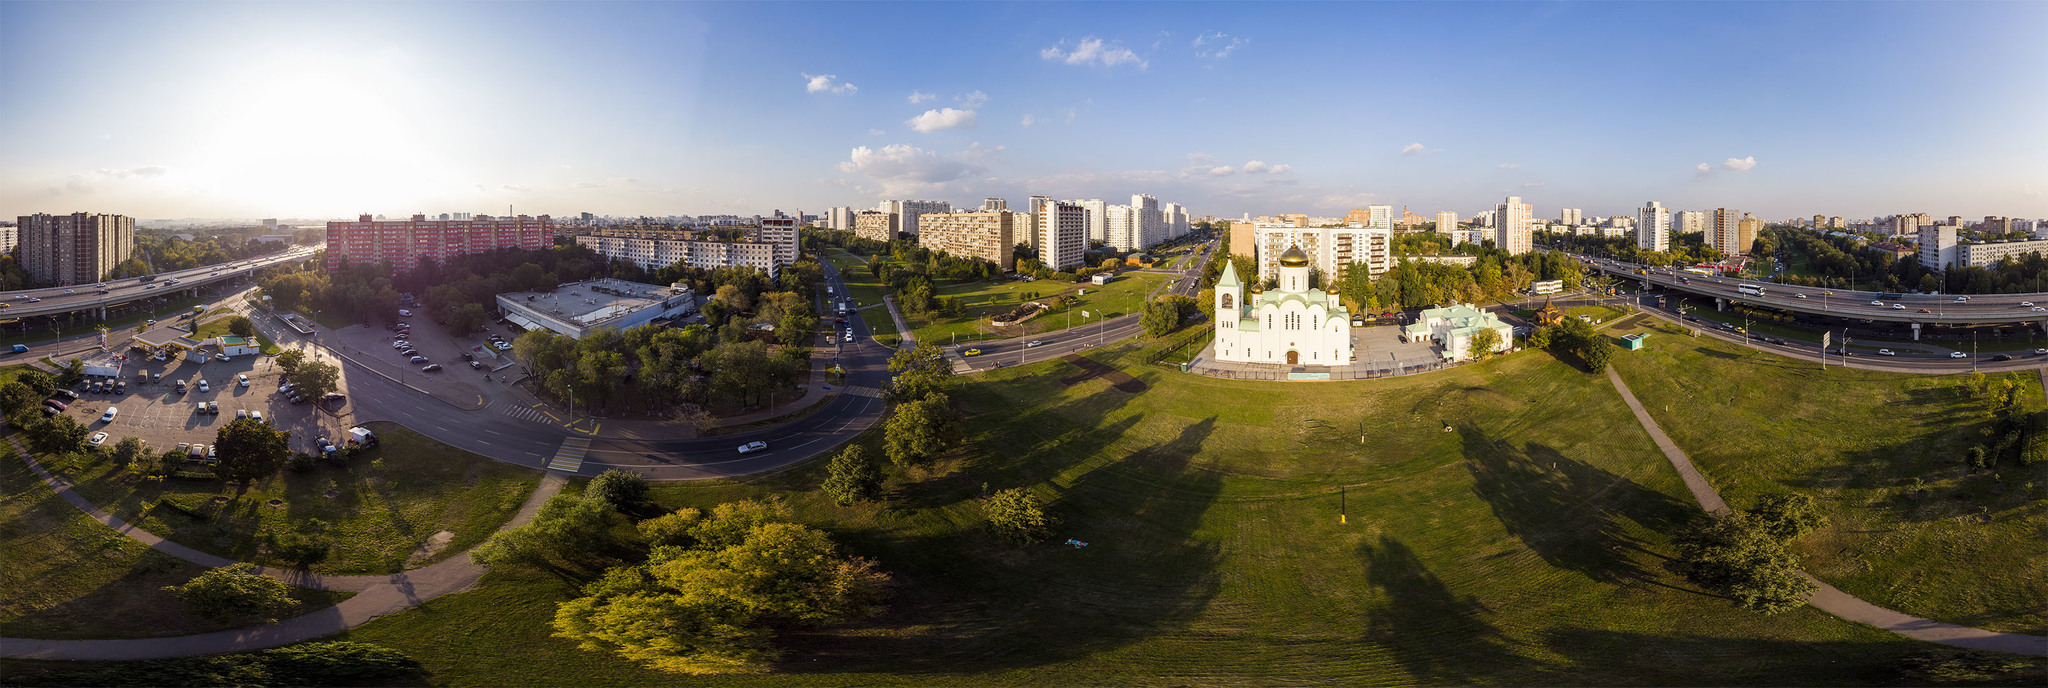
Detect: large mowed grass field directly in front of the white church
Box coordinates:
(323, 346, 2015, 686)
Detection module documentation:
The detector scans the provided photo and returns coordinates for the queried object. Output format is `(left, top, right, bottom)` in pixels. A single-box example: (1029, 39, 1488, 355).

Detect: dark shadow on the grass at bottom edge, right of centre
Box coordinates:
(1358, 536, 1532, 684)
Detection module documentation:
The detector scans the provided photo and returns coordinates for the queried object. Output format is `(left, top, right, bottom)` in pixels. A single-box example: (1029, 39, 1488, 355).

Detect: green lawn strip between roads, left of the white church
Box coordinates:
(905, 272, 1171, 344)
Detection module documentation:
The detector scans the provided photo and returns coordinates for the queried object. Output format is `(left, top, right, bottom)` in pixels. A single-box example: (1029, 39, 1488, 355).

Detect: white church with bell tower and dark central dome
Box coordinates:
(1217, 246, 1352, 367)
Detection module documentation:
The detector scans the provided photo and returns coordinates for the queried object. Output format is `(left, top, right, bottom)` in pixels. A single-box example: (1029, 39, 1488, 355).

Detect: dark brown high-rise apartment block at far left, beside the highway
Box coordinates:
(16, 213, 135, 287)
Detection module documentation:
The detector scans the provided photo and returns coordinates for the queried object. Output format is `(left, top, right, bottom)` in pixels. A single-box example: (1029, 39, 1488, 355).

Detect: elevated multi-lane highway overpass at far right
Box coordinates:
(1579, 256, 2048, 326)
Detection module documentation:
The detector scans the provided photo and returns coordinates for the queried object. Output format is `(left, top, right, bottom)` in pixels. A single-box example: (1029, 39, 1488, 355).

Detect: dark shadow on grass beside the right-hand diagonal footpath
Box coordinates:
(1458, 426, 1698, 584)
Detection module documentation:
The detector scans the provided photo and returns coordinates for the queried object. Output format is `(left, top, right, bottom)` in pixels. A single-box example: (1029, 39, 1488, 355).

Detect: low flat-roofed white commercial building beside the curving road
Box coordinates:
(498, 278, 696, 338)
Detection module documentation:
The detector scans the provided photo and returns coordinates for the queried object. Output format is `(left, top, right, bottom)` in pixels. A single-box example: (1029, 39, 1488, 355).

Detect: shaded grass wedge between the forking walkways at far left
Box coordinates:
(0, 438, 350, 639)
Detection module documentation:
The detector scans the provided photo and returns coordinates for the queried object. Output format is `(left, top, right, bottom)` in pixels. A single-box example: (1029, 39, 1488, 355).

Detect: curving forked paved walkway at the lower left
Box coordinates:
(0, 436, 565, 659)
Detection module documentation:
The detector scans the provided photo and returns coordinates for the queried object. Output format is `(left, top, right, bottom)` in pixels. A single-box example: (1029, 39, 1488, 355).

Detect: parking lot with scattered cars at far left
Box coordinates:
(51, 356, 348, 453)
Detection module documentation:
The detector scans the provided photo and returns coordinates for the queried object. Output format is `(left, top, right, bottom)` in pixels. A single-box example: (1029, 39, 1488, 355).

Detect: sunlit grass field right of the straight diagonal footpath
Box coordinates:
(1614, 317, 2048, 635)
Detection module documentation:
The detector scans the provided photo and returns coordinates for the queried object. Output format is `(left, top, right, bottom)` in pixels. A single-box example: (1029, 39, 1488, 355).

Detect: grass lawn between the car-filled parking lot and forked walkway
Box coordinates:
(38, 424, 539, 573)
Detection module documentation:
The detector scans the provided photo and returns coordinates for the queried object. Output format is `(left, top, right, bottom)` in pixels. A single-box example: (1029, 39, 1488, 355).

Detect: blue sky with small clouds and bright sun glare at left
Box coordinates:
(0, 2, 2048, 219)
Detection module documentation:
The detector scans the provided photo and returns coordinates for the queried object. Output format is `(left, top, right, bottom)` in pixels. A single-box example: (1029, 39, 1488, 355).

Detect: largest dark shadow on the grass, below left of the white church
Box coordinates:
(784, 413, 1223, 676)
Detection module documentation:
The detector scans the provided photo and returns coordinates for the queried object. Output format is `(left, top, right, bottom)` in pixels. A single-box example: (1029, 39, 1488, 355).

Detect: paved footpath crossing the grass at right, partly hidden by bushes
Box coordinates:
(1608, 367, 2048, 657)
